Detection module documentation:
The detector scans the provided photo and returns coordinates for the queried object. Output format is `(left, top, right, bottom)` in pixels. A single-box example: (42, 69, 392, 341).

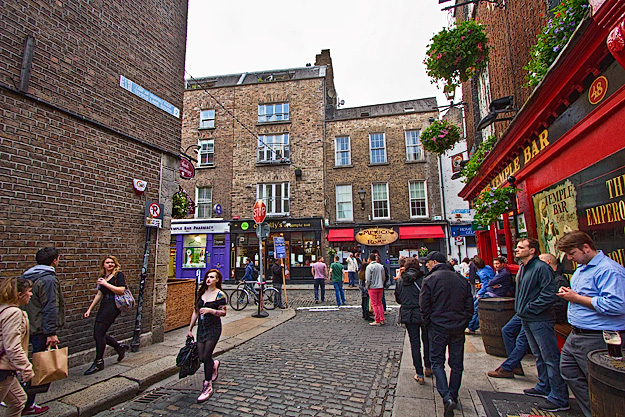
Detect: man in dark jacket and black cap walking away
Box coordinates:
(419, 251, 473, 417)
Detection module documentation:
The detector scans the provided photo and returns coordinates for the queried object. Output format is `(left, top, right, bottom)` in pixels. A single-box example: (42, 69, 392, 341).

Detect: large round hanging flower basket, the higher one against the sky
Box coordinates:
(423, 20, 489, 86)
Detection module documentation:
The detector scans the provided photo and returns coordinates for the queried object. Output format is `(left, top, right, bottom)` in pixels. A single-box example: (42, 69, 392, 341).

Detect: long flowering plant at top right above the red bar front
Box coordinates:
(523, 0, 588, 88)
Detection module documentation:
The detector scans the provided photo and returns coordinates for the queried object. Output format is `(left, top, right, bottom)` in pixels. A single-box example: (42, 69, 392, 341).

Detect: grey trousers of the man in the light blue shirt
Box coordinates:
(560, 333, 608, 417)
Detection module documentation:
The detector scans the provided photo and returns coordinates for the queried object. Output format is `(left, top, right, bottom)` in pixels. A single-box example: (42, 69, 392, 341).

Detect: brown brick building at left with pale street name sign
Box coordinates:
(0, 0, 187, 363)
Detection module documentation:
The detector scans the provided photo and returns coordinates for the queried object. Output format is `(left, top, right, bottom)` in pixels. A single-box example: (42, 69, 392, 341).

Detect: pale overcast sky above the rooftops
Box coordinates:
(185, 0, 451, 107)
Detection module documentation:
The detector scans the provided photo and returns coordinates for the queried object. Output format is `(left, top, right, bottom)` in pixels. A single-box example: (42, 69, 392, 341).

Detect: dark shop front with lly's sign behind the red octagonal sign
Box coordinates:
(230, 218, 322, 282)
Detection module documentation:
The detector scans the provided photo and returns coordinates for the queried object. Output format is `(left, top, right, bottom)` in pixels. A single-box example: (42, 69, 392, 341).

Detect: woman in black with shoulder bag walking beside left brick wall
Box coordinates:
(84, 255, 130, 375)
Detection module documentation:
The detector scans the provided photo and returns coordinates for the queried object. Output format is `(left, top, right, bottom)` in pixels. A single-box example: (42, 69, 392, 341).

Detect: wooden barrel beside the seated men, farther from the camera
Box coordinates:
(478, 297, 514, 358)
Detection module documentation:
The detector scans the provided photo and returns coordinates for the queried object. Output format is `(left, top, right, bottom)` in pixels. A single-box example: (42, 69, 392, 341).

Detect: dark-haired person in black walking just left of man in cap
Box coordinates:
(395, 258, 432, 385)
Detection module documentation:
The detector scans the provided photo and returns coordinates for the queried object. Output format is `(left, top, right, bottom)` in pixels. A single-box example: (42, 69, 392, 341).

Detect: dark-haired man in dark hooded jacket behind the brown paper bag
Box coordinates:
(22, 247, 65, 416)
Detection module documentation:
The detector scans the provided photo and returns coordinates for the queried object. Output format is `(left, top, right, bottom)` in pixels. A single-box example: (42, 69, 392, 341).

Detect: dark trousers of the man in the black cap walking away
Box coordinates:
(429, 327, 464, 402)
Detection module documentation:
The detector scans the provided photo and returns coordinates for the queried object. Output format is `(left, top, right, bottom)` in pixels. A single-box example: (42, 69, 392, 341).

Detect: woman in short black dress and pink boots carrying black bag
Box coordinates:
(187, 269, 226, 403)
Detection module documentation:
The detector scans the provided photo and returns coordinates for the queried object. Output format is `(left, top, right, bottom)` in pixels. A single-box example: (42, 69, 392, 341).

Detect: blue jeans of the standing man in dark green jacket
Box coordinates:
(522, 320, 569, 405)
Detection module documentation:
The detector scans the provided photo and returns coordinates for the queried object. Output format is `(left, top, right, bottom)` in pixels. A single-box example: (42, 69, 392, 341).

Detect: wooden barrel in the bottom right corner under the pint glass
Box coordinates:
(588, 350, 625, 417)
